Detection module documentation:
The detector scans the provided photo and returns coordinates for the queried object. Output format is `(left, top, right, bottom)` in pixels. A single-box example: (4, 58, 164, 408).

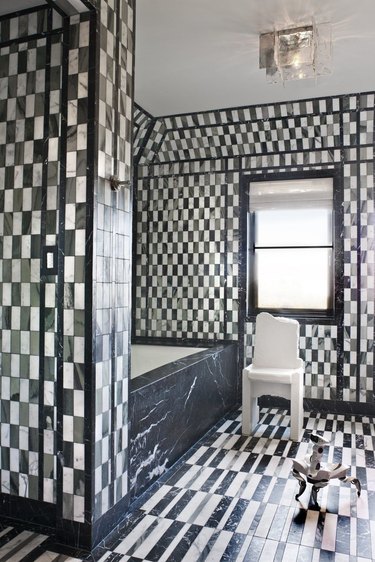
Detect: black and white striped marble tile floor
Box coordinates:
(0, 409, 375, 562)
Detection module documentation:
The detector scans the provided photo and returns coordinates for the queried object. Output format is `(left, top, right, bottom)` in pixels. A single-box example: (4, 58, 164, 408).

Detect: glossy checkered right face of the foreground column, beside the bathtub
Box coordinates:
(94, 0, 134, 519)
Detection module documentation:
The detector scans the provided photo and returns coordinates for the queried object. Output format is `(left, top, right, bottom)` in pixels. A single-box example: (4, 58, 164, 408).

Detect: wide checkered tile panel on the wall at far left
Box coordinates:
(0, 5, 61, 503)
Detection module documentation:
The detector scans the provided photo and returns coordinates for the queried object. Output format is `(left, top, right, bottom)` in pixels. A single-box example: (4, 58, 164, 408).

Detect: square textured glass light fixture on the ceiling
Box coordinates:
(259, 23, 332, 82)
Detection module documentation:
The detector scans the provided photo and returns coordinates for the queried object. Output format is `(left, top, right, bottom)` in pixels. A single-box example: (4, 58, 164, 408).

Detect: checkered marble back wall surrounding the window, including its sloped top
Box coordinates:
(134, 93, 375, 405)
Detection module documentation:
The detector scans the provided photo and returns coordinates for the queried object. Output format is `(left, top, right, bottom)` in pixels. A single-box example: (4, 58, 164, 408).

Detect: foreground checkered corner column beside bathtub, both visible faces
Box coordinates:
(57, 0, 134, 547)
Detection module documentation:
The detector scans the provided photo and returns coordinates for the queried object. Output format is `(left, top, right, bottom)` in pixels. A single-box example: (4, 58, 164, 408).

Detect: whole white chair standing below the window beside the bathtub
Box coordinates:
(242, 312, 304, 441)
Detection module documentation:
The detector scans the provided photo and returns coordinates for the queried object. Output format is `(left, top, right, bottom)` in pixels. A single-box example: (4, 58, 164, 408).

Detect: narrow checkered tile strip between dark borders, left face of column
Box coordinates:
(62, 14, 91, 522)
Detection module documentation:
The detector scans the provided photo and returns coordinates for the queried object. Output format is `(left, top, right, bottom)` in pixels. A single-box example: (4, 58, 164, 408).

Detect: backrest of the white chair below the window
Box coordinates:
(253, 312, 301, 369)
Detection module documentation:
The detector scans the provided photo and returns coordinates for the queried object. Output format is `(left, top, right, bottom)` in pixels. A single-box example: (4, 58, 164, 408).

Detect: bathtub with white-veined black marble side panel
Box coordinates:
(129, 342, 239, 500)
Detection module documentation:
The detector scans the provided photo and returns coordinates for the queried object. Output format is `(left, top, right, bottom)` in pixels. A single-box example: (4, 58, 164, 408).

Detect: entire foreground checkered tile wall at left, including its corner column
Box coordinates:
(0, 0, 134, 547)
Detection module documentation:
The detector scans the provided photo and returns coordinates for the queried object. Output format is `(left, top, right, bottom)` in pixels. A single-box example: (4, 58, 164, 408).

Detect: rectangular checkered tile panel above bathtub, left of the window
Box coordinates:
(137, 173, 226, 338)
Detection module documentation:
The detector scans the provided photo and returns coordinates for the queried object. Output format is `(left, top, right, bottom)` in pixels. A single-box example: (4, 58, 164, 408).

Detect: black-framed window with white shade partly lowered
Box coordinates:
(248, 173, 335, 317)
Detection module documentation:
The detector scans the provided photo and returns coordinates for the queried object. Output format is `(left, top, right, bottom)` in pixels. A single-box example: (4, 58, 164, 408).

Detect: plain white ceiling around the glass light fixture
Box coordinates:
(135, 0, 375, 116)
